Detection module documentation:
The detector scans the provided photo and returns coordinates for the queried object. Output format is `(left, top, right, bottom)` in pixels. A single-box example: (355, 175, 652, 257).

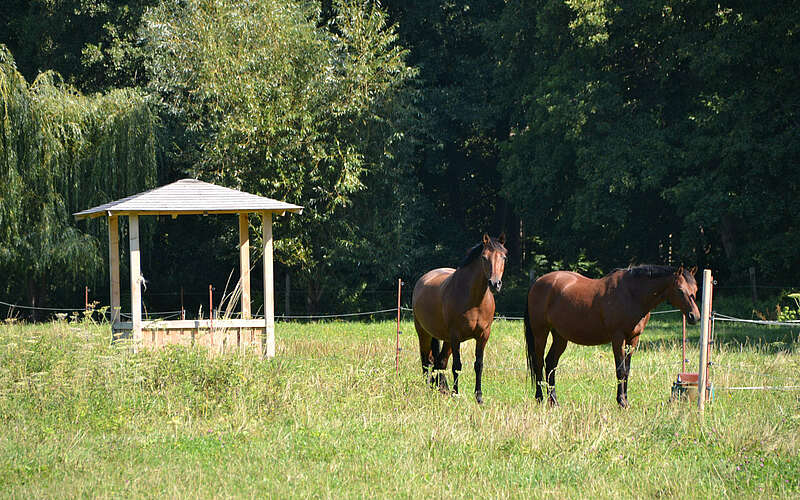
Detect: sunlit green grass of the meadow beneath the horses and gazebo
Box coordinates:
(0, 316, 800, 498)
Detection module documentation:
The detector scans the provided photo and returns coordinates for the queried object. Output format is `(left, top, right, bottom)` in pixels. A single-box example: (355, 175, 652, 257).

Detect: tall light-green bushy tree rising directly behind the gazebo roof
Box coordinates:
(143, 0, 414, 308)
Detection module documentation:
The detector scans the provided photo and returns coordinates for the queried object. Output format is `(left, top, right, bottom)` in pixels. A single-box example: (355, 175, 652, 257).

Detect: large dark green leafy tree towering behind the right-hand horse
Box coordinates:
(496, 0, 800, 284)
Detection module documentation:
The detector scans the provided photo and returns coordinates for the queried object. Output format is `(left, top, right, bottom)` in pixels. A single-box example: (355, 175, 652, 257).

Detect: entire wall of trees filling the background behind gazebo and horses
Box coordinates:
(0, 0, 800, 315)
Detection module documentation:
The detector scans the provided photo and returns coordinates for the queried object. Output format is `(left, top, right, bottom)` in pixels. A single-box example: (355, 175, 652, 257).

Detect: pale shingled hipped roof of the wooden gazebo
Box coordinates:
(73, 179, 303, 219)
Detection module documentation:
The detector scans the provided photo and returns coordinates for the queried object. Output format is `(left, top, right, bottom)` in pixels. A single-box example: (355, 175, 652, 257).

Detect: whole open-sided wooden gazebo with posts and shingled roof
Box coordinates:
(73, 179, 303, 357)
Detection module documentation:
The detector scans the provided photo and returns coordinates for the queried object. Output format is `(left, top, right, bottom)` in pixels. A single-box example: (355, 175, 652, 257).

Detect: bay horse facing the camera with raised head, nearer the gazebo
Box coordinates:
(412, 234, 507, 403)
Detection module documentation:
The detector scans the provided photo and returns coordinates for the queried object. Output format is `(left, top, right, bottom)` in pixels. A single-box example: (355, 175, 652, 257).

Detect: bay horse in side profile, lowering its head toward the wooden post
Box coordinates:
(525, 265, 700, 408)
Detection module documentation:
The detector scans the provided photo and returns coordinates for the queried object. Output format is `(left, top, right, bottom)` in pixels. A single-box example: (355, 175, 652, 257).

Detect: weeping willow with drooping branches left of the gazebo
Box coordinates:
(0, 46, 156, 312)
